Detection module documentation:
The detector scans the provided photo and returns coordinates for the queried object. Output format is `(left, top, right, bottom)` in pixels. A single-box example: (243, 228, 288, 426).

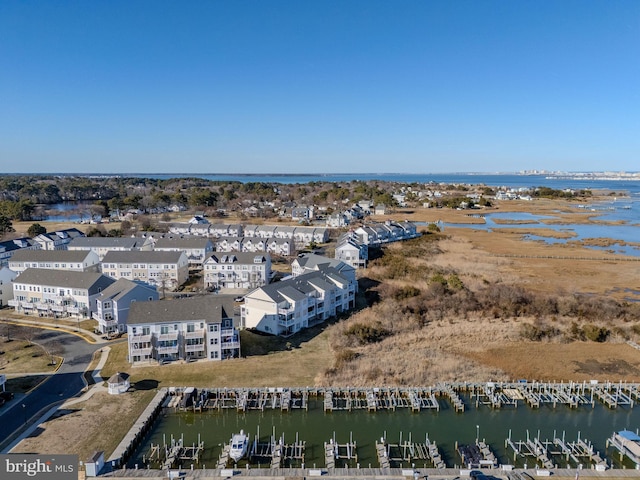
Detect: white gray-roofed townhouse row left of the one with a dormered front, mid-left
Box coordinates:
(102, 251, 189, 290)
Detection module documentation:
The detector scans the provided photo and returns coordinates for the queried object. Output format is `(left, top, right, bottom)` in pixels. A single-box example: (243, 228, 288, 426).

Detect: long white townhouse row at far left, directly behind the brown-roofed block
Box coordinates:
(9, 250, 100, 273)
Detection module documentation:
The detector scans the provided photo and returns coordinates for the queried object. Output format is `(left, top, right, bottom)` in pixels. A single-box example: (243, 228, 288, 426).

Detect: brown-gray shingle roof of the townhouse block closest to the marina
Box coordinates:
(127, 295, 234, 324)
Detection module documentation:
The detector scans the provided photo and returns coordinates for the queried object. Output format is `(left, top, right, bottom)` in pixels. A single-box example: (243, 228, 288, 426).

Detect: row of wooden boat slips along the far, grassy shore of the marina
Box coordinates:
(163, 381, 640, 413)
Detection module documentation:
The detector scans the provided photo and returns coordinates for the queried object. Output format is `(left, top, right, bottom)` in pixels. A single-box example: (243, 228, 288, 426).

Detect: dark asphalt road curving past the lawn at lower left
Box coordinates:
(0, 330, 102, 450)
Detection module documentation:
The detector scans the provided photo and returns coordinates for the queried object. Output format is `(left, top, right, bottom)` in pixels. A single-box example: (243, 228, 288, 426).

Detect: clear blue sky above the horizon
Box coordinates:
(0, 0, 640, 173)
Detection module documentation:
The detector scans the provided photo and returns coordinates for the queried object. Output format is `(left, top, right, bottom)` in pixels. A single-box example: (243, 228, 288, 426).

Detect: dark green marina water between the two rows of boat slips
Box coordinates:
(128, 395, 640, 468)
